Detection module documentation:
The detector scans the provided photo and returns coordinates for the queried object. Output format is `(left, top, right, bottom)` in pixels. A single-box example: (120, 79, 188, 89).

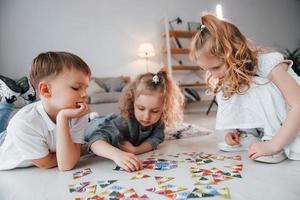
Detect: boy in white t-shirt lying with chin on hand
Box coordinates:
(0, 52, 91, 171)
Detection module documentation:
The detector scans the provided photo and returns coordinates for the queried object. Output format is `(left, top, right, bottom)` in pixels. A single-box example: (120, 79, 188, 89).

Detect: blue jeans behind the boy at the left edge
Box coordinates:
(0, 103, 15, 145)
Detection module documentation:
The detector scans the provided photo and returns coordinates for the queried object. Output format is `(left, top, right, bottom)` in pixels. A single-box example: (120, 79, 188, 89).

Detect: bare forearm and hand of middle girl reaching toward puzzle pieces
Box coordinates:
(90, 140, 142, 171)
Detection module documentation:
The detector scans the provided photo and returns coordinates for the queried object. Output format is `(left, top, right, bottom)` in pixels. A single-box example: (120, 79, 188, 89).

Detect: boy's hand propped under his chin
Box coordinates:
(57, 103, 90, 118)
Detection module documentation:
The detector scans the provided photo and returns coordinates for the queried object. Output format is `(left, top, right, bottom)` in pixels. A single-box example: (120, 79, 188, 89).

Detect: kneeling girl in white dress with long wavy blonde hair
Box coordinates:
(190, 14, 300, 163)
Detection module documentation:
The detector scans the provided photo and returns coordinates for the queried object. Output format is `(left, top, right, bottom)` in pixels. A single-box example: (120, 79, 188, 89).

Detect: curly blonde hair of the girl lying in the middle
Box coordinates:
(120, 70, 184, 128)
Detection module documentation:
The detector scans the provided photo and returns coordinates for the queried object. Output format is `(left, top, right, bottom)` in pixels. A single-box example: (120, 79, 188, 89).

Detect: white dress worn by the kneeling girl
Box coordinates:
(216, 52, 300, 160)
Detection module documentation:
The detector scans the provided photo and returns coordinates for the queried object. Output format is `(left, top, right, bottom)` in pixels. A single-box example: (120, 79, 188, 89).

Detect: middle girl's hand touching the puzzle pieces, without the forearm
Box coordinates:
(113, 151, 143, 172)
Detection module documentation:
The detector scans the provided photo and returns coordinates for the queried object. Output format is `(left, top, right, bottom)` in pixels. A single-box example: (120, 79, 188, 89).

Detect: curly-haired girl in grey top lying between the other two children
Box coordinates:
(86, 70, 184, 171)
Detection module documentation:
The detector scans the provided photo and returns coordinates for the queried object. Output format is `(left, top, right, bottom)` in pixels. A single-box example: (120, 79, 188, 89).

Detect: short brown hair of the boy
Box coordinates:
(29, 51, 91, 88)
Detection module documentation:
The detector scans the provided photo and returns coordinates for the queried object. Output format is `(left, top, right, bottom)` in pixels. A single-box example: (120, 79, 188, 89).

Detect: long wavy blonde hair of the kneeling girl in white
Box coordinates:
(190, 14, 260, 98)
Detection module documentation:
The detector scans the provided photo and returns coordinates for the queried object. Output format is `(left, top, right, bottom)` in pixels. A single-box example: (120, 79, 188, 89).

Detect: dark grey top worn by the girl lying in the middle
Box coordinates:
(85, 114, 165, 150)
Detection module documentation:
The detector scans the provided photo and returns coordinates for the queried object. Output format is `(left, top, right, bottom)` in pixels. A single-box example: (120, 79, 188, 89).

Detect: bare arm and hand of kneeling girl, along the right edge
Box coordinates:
(248, 63, 300, 159)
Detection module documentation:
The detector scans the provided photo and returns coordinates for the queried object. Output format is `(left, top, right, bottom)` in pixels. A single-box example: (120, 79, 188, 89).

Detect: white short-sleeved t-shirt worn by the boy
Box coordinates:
(0, 101, 88, 170)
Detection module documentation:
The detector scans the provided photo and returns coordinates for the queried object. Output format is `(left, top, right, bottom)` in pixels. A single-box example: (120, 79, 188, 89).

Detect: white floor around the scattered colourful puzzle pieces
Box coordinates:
(0, 112, 300, 200)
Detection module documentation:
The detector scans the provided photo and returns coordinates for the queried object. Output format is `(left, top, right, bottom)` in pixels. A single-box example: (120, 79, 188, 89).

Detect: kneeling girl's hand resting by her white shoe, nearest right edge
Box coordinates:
(248, 140, 280, 160)
